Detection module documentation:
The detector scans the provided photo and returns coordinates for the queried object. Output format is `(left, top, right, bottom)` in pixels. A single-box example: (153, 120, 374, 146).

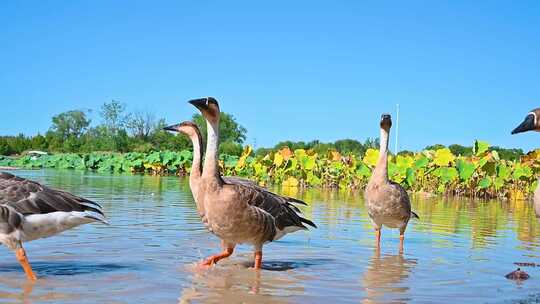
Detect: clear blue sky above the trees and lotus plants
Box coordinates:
(0, 1, 540, 150)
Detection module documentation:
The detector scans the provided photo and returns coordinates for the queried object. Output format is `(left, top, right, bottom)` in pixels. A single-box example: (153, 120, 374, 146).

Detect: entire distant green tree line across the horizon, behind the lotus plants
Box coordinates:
(0, 100, 524, 160)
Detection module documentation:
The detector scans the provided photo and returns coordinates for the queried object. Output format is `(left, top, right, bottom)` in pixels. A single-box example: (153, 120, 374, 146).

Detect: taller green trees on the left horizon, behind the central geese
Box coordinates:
(0, 100, 247, 155)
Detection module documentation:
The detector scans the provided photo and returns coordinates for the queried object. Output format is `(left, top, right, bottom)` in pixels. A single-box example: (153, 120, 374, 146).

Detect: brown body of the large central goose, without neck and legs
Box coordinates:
(194, 178, 315, 248)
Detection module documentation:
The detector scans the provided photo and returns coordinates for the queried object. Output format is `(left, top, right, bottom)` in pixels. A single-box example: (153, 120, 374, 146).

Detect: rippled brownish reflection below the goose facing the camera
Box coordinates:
(361, 250, 417, 303)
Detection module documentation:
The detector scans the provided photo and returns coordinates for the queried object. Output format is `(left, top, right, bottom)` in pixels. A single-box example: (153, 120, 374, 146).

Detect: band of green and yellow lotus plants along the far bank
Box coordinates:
(0, 141, 540, 199)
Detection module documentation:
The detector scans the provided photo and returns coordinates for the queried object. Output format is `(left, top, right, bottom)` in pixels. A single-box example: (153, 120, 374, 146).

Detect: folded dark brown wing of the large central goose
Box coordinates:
(223, 177, 317, 230)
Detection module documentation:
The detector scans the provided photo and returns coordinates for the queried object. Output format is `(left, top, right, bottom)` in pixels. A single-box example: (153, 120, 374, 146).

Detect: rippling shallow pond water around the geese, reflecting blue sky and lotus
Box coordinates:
(0, 170, 540, 303)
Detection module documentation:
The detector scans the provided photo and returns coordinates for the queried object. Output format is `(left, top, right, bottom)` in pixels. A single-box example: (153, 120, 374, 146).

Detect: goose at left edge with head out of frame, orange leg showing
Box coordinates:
(0, 172, 107, 280)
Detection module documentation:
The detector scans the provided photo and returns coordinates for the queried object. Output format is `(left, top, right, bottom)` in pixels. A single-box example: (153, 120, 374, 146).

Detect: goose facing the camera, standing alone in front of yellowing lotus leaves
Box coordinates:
(364, 114, 418, 252)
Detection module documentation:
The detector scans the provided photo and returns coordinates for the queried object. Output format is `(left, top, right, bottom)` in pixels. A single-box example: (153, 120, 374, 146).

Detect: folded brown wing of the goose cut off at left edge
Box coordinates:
(0, 172, 106, 223)
